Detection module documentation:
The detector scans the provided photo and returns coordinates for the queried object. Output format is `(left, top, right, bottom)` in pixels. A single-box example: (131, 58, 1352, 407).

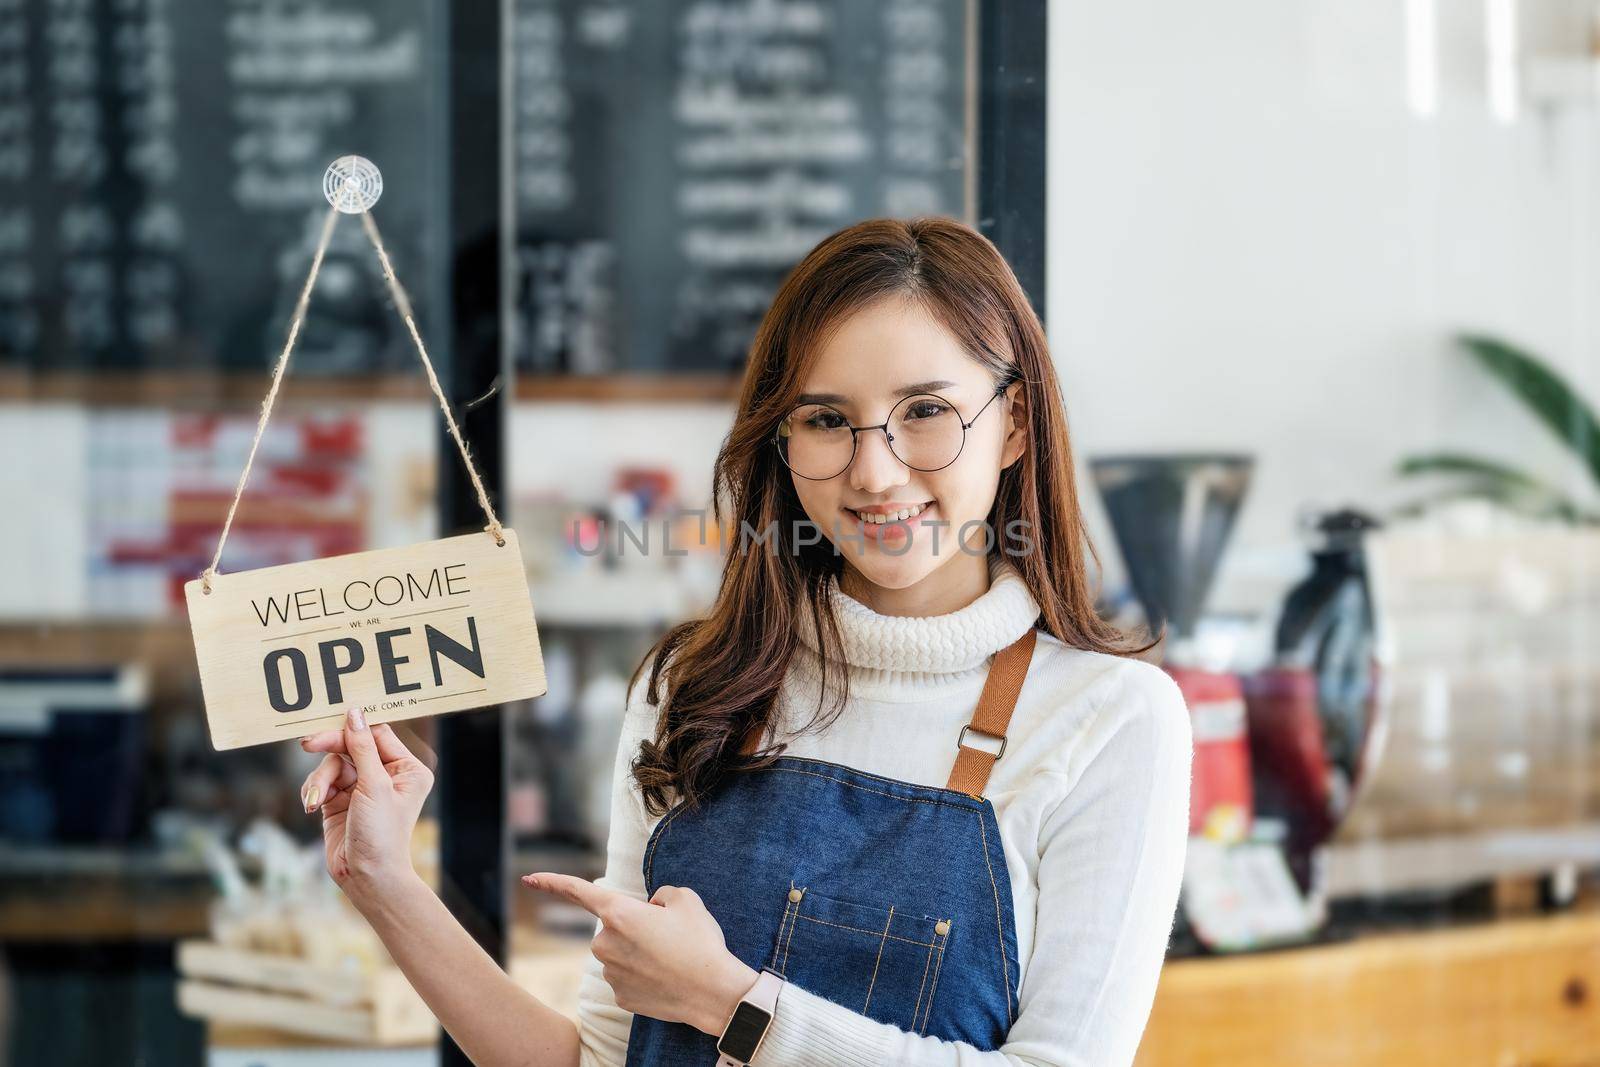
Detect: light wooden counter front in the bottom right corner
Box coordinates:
(1136, 912, 1600, 1067)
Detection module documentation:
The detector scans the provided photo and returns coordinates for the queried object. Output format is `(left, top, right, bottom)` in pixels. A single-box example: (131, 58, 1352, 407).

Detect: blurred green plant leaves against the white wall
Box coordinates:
(1392, 333, 1600, 525)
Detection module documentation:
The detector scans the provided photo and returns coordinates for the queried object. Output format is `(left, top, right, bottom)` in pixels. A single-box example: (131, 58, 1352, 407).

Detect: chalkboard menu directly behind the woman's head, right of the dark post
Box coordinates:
(512, 0, 976, 374)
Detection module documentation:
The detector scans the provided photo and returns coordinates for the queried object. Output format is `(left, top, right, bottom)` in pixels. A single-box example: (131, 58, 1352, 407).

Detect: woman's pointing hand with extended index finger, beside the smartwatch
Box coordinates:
(523, 872, 760, 1035)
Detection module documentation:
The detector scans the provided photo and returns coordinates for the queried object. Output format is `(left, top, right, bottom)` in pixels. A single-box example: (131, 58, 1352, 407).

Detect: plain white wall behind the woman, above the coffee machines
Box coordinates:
(1046, 0, 1600, 611)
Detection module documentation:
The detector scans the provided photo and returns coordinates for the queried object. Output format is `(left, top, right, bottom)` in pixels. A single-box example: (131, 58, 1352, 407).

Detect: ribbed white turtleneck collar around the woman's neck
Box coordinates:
(795, 553, 1040, 699)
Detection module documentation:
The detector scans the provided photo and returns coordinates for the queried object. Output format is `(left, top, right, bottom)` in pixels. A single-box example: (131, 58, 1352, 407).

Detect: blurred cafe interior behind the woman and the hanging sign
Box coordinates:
(0, 0, 1600, 1067)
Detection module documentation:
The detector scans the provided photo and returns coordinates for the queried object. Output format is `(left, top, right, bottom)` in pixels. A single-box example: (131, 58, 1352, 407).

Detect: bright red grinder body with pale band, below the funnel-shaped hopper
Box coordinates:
(1163, 665, 1254, 843)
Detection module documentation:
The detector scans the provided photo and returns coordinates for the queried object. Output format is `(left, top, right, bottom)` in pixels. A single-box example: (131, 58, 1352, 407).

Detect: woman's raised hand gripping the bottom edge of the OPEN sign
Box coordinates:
(301, 707, 434, 907)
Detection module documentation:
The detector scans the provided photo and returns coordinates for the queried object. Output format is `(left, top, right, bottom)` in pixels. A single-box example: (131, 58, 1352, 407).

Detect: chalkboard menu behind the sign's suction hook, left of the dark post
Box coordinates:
(0, 0, 442, 374)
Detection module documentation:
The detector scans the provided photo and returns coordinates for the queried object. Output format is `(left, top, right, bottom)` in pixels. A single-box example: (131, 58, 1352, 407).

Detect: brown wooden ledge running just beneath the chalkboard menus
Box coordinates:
(0, 365, 741, 410)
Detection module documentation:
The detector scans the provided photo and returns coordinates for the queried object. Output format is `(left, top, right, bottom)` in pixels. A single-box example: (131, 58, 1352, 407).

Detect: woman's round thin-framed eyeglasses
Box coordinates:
(773, 378, 1016, 482)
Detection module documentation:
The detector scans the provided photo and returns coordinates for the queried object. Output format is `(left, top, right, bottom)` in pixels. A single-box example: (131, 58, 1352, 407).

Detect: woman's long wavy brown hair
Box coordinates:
(629, 218, 1155, 814)
